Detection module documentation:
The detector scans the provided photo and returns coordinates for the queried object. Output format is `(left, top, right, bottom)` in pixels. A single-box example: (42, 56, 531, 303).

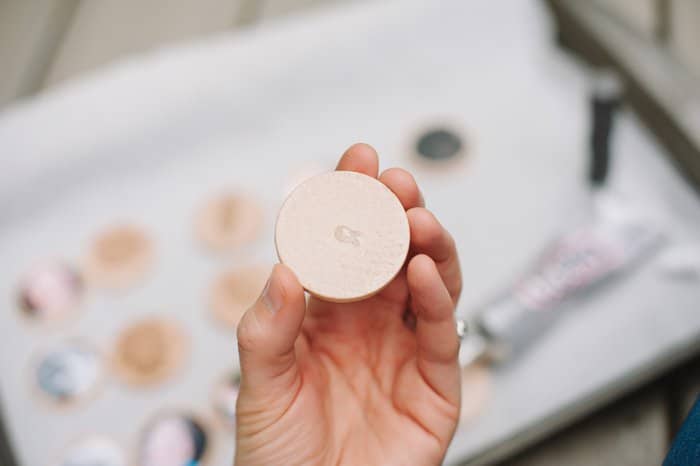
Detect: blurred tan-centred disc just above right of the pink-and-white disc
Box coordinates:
(85, 225, 154, 288)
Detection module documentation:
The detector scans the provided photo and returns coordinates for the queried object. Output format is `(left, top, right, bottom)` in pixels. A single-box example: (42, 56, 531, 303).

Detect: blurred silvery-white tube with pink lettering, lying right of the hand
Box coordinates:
(460, 204, 663, 364)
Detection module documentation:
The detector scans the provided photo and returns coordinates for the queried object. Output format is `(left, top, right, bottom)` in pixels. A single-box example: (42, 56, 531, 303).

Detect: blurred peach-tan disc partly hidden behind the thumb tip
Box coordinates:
(210, 266, 270, 328)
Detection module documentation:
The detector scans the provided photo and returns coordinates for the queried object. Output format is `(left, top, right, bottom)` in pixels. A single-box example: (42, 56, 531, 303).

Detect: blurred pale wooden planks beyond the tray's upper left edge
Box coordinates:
(0, 0, 356, 105)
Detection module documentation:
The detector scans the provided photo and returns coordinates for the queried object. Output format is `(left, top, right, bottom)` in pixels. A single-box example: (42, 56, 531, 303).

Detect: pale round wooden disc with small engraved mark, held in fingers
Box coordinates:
(275, 171, 410, 302)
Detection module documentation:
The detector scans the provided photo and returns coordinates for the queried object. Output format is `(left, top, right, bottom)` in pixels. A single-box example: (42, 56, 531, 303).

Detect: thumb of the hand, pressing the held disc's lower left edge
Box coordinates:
(238, 264, 306, 396)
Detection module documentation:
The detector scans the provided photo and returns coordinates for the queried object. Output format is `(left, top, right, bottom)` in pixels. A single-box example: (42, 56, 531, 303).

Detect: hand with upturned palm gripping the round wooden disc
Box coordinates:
(236, 144, 462, 466)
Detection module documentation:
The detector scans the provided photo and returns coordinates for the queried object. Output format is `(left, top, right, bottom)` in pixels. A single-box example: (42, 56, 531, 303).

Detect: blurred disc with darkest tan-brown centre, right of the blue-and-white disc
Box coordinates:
(113, 318, 186, 386)
